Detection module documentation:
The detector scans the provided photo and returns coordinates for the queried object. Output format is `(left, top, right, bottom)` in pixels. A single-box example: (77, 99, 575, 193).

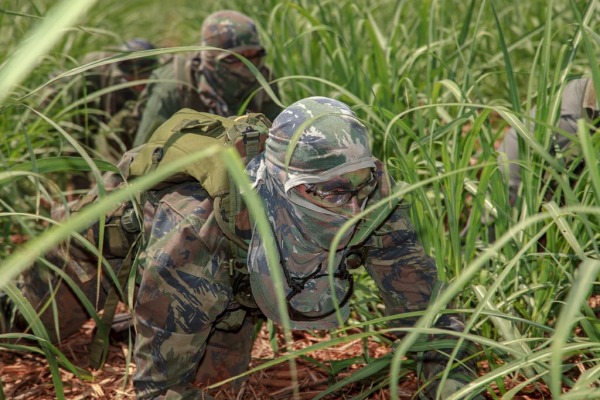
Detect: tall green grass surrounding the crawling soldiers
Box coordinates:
(0, 0, 600, 399)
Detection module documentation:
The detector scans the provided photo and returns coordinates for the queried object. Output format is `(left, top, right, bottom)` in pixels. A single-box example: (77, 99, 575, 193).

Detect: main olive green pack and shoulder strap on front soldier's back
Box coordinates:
(129, 108, 271, 258)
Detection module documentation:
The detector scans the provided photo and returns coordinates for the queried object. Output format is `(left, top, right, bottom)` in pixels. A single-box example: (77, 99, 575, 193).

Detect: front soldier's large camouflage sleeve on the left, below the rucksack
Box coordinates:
(134, 183, 232, 399)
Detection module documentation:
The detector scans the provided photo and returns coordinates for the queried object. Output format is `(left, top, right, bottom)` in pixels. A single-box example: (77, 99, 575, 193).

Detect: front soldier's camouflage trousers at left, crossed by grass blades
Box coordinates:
(0, 142, 160, 343)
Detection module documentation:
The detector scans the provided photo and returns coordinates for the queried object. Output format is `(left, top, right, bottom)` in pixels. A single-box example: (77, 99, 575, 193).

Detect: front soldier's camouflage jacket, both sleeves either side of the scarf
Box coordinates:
(134, 156, 437, 398)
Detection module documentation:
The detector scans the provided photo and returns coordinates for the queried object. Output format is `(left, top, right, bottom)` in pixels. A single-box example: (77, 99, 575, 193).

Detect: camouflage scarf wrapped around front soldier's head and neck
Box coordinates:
(248, 97, 375, 329)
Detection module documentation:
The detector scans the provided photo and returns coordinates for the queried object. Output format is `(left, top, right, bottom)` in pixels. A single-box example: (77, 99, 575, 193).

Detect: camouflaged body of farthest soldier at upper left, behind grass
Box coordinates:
(35, 39, 159, 162)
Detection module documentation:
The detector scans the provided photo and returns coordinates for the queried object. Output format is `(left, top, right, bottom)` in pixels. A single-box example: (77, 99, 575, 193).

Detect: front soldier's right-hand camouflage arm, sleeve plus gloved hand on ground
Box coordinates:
(366, 198, 480, 392)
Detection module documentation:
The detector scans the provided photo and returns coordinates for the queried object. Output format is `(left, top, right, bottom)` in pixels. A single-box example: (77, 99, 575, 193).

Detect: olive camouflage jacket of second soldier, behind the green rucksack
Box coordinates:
(133, 56, 281, 147)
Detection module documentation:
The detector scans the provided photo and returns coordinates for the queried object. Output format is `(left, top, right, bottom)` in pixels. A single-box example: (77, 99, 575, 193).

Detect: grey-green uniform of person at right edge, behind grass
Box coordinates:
(498, 78, 600, 204)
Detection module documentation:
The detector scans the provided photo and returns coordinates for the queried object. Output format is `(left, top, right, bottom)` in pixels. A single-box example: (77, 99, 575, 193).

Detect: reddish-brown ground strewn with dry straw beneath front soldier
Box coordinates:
(0, 320, 416, 400)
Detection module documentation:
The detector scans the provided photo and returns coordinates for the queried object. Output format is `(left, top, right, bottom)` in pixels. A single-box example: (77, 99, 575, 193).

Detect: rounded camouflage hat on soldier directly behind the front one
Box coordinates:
(201, 10, 262, 50)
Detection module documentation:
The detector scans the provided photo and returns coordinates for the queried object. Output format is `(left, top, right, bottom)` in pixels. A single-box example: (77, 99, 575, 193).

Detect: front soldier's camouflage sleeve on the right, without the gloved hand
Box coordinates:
(365, 205, 437, 326)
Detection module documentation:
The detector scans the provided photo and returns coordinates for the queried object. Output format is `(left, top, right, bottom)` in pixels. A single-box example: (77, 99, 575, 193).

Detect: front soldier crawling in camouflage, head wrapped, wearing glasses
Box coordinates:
(0, 97, 486, 399)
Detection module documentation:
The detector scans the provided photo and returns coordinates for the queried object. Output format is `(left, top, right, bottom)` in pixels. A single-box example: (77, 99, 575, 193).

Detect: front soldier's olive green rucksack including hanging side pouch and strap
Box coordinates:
(86, 108, 271, 369)
